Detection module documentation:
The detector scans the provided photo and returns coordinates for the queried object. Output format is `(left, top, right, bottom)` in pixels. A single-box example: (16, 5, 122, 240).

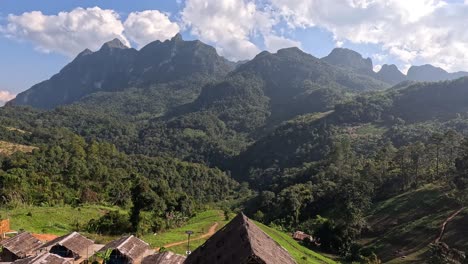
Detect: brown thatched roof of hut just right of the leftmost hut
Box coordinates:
(42, 232, 94, 256)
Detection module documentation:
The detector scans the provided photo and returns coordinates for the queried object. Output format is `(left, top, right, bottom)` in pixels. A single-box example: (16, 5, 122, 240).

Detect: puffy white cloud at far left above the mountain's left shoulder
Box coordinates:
(0, 7, 129, 56)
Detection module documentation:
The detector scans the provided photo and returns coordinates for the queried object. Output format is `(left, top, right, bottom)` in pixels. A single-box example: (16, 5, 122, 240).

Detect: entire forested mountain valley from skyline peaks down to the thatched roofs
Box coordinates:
(0, 34, 468, 263)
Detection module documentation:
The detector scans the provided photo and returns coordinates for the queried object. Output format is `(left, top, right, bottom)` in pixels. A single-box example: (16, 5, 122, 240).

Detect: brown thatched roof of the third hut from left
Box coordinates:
(99, 235, 150, 261)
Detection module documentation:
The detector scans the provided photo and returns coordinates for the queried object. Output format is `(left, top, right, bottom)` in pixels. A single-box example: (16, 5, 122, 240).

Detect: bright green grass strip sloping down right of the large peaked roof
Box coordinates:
(252, 222, 336, 264)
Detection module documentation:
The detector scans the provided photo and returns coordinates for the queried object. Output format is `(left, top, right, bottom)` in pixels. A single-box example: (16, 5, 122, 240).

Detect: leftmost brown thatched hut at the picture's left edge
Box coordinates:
(0, 232, 42, 262)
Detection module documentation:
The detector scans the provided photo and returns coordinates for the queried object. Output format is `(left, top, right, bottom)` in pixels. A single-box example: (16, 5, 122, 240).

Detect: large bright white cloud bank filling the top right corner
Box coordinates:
(270, 0, 468, 70)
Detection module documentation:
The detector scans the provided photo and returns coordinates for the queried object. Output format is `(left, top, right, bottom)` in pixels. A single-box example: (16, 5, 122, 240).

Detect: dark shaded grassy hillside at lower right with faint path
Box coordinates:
(365, 185, 459, 263)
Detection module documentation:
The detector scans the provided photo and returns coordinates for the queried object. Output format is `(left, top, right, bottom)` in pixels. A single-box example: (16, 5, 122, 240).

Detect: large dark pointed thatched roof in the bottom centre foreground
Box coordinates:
(185, 213, 296, 264)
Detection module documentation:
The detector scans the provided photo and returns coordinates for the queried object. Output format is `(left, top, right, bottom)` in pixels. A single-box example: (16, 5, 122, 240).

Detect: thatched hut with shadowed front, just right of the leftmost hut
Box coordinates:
(39, 232, 95, 263)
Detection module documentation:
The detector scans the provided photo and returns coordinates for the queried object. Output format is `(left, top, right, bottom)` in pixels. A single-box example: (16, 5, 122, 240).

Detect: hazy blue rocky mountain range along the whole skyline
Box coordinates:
(9, 34, 468, 109)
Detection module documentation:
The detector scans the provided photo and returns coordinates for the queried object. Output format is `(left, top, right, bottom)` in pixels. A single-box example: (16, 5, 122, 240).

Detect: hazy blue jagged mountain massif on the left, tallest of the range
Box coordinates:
(10, 35, 234, 109)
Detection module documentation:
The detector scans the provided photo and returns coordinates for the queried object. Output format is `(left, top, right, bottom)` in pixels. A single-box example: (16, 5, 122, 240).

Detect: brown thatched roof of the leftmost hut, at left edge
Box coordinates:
(0, 232, 42, 258)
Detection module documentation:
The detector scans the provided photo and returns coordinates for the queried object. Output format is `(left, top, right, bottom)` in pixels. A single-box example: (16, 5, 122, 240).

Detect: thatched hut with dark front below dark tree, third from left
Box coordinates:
(98, 235, 154, 264)
